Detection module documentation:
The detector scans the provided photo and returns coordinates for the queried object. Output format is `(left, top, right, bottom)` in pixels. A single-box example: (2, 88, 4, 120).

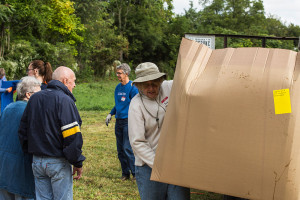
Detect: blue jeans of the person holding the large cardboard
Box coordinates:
(135, 165, 190, 200)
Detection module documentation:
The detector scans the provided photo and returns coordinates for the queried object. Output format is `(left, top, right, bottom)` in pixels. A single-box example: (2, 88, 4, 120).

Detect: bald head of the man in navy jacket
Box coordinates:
(52, 66, 76, 92)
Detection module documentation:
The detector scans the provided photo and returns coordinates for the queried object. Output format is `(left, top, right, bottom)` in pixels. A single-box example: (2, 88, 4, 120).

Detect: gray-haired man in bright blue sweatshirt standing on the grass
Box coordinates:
(105, 63, 138, 180)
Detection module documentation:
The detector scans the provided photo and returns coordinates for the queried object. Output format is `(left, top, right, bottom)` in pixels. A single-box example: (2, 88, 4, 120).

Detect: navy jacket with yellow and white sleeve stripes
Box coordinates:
(19, 80, 85, 168)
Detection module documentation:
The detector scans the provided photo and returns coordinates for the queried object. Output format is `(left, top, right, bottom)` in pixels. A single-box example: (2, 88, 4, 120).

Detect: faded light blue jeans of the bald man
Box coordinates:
(32, 156, 73, 200)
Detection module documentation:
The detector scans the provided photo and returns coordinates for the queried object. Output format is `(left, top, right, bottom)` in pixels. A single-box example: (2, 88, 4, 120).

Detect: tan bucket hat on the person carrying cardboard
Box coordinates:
(132, 62, 166, 83)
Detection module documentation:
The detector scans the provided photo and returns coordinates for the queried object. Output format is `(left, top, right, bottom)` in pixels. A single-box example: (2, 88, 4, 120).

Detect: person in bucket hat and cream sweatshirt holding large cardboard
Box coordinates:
(128, 62, 190, 200)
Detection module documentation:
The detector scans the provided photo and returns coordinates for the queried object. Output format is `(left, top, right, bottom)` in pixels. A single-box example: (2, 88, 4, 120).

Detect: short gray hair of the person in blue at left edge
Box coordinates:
(17, 76, 41, 100)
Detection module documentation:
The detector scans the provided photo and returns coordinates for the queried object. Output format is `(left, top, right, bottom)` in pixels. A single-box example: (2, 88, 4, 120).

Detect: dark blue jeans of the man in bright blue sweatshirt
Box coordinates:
(115, 119, 135, 176)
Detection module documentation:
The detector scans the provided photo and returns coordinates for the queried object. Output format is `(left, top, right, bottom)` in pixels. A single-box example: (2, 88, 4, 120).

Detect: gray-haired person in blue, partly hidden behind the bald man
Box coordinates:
(0, 76, 41, 200)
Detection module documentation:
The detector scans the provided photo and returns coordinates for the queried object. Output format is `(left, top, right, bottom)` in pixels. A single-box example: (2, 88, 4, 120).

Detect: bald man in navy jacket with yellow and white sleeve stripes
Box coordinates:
(19, 66, 85, 200)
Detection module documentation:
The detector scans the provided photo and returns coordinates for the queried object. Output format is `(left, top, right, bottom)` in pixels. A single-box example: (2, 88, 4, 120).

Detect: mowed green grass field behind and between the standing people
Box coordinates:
(74, 79, 222, 200)
